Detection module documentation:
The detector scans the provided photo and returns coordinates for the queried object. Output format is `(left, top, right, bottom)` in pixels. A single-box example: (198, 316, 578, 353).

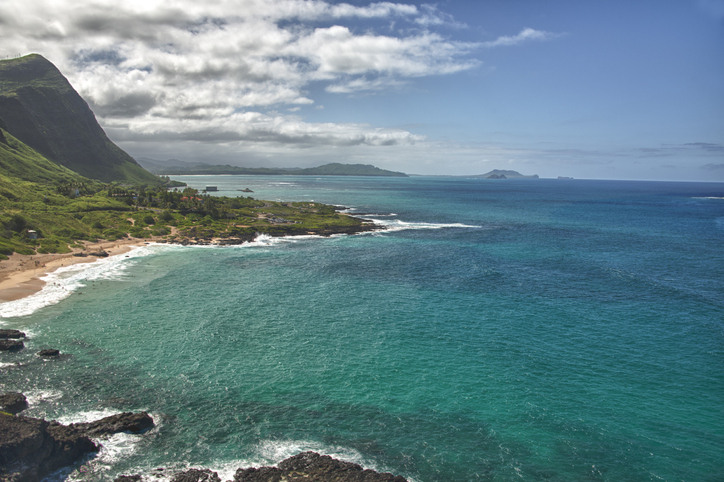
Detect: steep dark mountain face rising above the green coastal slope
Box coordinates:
(0, 55, 158, 184)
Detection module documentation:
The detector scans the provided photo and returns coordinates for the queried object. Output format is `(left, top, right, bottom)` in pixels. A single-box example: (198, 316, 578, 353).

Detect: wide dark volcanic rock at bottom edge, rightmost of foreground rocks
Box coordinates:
(234, 452, 407, 482)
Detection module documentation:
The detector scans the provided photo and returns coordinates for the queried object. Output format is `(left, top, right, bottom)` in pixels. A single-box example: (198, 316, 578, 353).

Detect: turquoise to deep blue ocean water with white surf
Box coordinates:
(0, 176, 724, 482)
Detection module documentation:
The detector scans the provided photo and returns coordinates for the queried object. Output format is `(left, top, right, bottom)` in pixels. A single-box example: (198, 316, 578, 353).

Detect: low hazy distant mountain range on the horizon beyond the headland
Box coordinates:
(137, 157, 407, 177)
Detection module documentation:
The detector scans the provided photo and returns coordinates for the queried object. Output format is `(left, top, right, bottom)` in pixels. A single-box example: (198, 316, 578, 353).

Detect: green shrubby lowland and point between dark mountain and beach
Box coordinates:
(0, 129, 369, 259)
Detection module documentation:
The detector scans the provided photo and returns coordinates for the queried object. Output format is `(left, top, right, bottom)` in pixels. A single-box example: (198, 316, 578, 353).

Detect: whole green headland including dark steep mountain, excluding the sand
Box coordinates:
(0, 55, 376, 259)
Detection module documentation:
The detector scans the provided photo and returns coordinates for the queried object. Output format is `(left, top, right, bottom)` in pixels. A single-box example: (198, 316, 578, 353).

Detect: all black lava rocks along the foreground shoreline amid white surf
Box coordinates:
(0, 330, 406, 482)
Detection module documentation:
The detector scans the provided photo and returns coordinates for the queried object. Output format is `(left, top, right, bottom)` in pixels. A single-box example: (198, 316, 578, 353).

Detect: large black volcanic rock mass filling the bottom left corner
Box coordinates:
(0, 414, 98, 482)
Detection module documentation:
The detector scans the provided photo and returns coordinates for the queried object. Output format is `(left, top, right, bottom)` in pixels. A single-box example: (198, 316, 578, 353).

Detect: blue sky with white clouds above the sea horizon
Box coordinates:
(0, 0, 724, 181)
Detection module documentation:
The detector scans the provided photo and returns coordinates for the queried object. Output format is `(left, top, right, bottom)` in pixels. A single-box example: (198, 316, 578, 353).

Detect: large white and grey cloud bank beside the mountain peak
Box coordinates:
(0, 0, 486, 153)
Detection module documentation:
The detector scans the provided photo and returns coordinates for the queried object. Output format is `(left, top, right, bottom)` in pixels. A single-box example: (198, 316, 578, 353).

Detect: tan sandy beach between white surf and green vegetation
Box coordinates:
(0, 238, 153, 302)
